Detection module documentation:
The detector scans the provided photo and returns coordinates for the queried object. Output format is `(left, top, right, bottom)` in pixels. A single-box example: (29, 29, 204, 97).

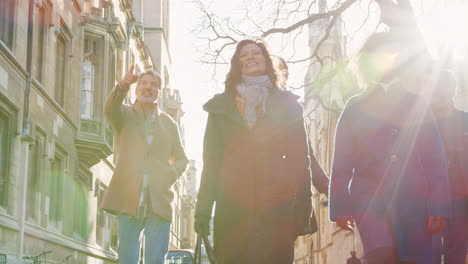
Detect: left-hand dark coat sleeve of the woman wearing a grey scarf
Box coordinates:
(195, 113, 224, 223)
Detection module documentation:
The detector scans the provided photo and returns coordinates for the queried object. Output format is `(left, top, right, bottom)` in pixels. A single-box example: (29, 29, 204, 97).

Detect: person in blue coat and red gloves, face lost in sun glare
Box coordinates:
(329, 33, 451, 264)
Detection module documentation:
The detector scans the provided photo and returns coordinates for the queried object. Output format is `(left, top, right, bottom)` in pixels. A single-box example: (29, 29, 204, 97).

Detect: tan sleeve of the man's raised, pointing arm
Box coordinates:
(104, 84, 128, 130)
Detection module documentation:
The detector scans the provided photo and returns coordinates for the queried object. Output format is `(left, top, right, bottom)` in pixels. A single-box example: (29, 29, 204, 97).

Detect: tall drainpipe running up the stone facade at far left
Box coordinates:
(18, 0, 35, 259)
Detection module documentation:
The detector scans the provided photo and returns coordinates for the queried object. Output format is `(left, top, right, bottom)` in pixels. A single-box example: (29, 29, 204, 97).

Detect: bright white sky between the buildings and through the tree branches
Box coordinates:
(170, 0, 468, 184)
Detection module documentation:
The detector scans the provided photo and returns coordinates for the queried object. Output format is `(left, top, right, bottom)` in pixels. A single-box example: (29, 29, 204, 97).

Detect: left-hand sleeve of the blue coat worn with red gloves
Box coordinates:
(328, 104, 354, 221)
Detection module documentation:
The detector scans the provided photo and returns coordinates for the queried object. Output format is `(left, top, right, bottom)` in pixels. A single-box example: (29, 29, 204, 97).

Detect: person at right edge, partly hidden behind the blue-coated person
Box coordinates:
(428, 71, 468, 264)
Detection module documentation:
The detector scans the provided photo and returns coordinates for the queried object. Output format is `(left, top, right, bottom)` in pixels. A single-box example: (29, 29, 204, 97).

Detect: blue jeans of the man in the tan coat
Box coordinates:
(118, 215, 171, 264)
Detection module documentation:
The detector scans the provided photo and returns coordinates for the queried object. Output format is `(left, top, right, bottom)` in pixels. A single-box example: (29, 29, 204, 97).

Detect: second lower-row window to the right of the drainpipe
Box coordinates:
(46, 147, 66, 230)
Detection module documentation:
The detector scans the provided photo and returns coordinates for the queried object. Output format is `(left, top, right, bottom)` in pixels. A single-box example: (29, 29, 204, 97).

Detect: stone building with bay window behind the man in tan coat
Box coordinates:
(0, 0, 195, 264)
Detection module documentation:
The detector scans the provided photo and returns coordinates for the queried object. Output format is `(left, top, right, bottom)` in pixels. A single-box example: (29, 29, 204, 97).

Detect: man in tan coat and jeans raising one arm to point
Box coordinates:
(101, 66, 188, 264)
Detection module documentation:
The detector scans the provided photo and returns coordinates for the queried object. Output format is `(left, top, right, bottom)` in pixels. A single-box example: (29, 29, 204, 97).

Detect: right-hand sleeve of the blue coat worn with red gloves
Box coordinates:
(419, 110, 451, 218)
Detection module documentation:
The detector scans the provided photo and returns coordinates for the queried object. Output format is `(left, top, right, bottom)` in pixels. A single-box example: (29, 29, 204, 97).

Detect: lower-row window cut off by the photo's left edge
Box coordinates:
(0, 98, 16, 208)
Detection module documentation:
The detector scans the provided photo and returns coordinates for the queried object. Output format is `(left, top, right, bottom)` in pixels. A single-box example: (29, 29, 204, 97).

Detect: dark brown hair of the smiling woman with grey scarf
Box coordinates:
(224, 39, 278, 96)
